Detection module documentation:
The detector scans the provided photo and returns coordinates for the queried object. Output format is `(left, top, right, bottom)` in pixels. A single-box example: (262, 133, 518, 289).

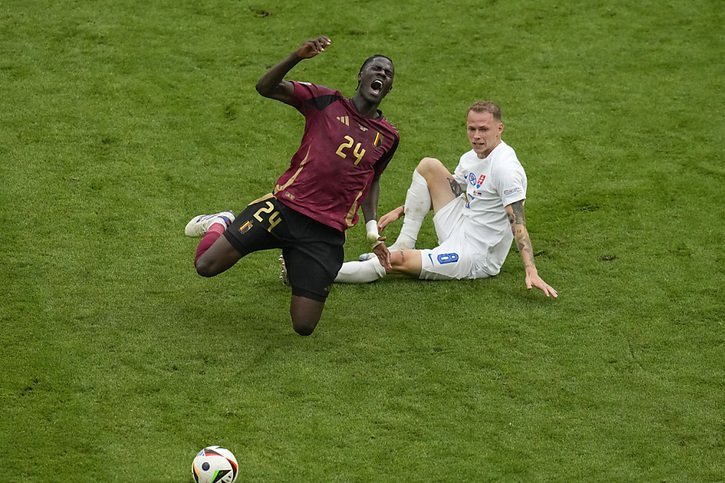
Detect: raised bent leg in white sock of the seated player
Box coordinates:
(390, 158, 457, 250)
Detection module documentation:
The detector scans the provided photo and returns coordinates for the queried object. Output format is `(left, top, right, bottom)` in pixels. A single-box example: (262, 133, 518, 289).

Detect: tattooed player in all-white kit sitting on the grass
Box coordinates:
(335, 101, 558, 298)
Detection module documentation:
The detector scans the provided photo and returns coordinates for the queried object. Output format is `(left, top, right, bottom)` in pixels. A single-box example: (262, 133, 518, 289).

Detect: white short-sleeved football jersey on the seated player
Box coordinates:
(453, 141, 526, 273)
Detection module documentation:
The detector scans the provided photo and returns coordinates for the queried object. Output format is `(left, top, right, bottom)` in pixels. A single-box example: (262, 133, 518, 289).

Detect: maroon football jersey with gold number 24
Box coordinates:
(274, 82, 400, 231)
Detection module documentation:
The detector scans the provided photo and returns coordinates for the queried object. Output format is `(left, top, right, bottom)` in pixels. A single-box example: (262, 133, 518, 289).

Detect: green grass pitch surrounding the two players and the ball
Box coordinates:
(0, 0, 725, 482)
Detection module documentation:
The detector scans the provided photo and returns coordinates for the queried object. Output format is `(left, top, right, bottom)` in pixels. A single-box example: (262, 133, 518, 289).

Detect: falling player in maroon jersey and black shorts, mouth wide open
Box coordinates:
(185, 36, 399, 335)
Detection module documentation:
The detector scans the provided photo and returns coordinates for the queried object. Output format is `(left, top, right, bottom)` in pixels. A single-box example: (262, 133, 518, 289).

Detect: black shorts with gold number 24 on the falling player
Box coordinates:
(224, 195, 345, 302)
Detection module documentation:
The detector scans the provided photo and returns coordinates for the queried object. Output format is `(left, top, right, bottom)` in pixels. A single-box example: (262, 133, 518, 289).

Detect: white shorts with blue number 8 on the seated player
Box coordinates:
(420, 196, 495, 280)
